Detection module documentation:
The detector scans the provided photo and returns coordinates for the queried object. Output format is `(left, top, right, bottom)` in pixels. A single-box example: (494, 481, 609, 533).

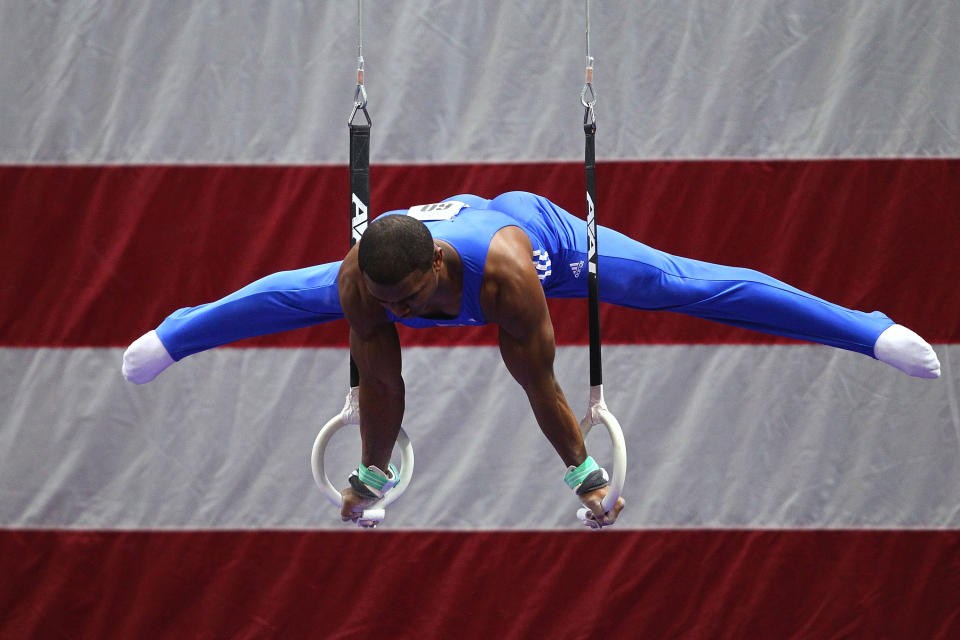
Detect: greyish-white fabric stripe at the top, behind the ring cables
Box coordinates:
(0, 0, 960, 164)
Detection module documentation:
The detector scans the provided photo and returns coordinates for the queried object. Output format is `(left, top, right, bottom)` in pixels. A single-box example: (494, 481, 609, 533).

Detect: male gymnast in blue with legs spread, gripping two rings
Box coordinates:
(122, 191, 940, 527)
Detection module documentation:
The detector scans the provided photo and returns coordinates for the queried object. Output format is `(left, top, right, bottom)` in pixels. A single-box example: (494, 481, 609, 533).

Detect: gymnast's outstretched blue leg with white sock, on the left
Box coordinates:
(122, 262, 343, 384)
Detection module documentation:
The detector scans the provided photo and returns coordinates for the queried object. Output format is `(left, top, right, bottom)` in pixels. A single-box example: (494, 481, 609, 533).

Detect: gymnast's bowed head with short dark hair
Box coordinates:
(357, 215, 442, 317)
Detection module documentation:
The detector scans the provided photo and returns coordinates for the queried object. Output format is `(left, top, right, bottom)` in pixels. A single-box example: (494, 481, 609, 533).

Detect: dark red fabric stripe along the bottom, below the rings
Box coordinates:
(0, 530, 960, 640)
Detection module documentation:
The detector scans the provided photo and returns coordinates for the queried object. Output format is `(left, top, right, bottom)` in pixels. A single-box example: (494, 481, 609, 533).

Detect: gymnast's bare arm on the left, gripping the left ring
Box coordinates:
(337, 249, 404, 519)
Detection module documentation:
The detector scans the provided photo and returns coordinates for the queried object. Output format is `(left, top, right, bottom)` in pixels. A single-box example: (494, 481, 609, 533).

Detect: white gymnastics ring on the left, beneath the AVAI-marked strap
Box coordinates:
(310, 387, 413, 527)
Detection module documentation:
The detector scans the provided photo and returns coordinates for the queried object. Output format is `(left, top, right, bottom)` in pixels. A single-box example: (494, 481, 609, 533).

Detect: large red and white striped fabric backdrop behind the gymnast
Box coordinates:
(0, 0, 960, 638)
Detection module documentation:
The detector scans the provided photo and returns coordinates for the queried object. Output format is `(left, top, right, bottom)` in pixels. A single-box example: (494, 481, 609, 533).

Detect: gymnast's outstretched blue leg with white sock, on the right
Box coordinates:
(548, 212, 940, 378)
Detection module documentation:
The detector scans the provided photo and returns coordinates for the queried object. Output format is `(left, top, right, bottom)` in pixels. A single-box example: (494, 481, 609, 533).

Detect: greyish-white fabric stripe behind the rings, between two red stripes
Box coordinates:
(0, 345, 960, 529)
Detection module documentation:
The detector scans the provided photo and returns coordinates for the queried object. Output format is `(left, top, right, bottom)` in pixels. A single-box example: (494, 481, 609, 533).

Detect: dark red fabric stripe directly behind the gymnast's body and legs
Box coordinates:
(0, 159, 960, 346)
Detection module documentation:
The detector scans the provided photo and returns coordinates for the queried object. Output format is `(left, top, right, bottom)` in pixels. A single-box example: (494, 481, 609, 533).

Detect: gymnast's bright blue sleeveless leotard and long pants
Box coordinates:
(157, 191, 893, 360)
